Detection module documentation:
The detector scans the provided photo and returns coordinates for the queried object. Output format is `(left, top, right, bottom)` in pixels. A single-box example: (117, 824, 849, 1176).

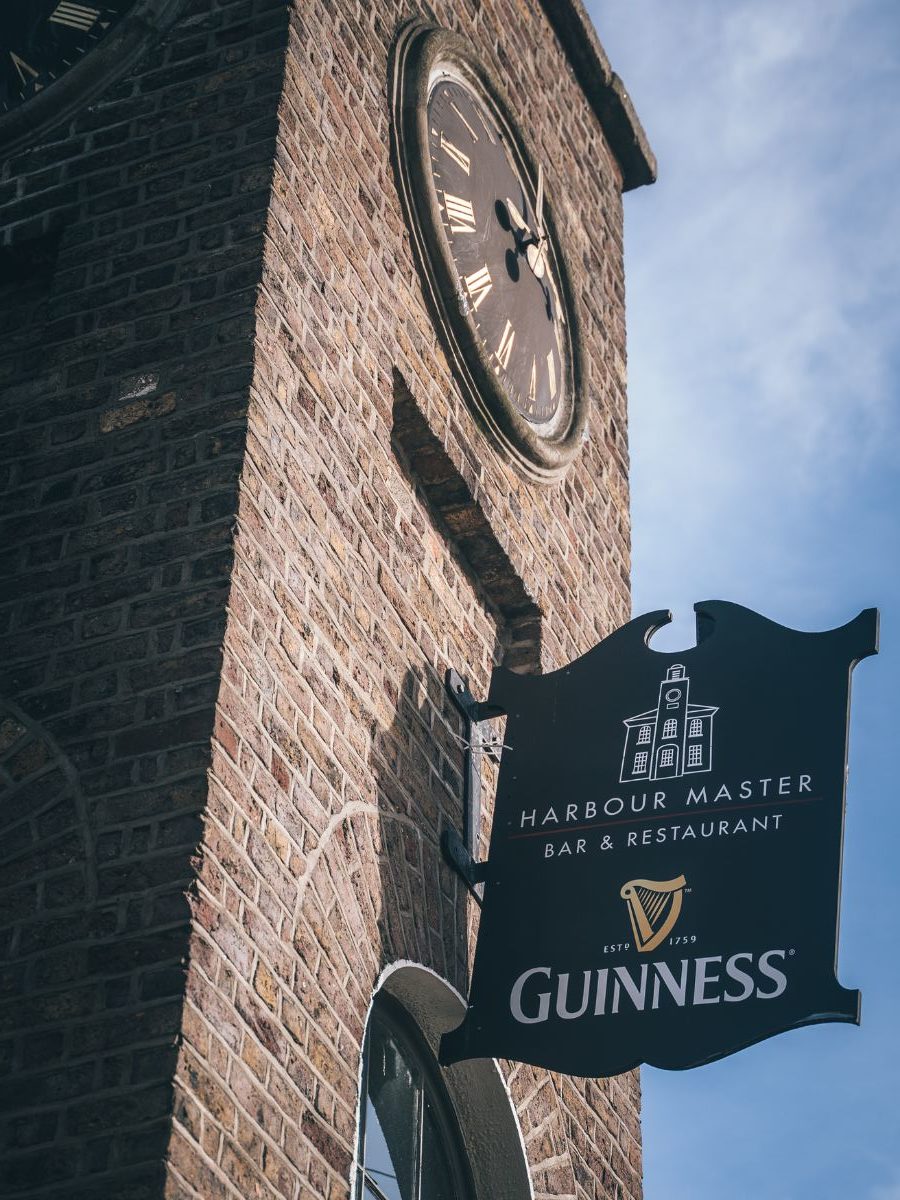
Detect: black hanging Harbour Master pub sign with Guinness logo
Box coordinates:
(440, 601, 877, 1076)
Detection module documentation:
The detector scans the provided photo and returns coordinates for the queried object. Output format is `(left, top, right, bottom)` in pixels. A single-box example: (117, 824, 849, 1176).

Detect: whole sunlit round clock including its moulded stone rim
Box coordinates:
(392, 24, 586, 480)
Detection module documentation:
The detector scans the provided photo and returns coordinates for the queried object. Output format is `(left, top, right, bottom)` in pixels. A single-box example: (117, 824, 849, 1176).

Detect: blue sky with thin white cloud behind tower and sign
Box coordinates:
(588, 0, 900, 1200)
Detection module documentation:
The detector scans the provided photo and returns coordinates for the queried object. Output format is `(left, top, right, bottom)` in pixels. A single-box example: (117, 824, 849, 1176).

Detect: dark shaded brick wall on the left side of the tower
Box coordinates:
(0, 0, 287, 1200)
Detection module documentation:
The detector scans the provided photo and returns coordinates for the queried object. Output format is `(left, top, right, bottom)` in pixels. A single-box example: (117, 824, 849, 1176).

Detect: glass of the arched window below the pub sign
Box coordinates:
(355, 996, 474, 1200)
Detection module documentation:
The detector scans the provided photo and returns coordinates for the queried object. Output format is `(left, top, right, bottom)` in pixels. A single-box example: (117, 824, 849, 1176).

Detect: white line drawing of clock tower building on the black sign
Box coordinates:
(619, 664, 719, 784)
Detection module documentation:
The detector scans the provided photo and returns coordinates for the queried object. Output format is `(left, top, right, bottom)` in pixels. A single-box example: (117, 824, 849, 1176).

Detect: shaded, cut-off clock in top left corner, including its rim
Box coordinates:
(0, 0, 181, 151)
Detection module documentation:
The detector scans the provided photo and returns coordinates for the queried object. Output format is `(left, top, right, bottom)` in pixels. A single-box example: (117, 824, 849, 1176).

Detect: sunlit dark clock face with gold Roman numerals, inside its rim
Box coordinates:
(427, 72, 571, 427)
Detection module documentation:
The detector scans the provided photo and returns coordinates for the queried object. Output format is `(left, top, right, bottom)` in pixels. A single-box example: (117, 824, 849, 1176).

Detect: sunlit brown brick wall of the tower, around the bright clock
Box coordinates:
(168, 2, 641, 1200)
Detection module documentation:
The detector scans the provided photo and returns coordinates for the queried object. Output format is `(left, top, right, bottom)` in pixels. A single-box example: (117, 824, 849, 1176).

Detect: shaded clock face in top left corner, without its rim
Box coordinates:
(0, 0, 134, 114)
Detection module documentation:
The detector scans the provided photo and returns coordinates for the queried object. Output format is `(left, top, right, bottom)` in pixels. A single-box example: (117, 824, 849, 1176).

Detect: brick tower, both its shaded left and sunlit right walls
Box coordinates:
(0, 0, 654, 1200)
